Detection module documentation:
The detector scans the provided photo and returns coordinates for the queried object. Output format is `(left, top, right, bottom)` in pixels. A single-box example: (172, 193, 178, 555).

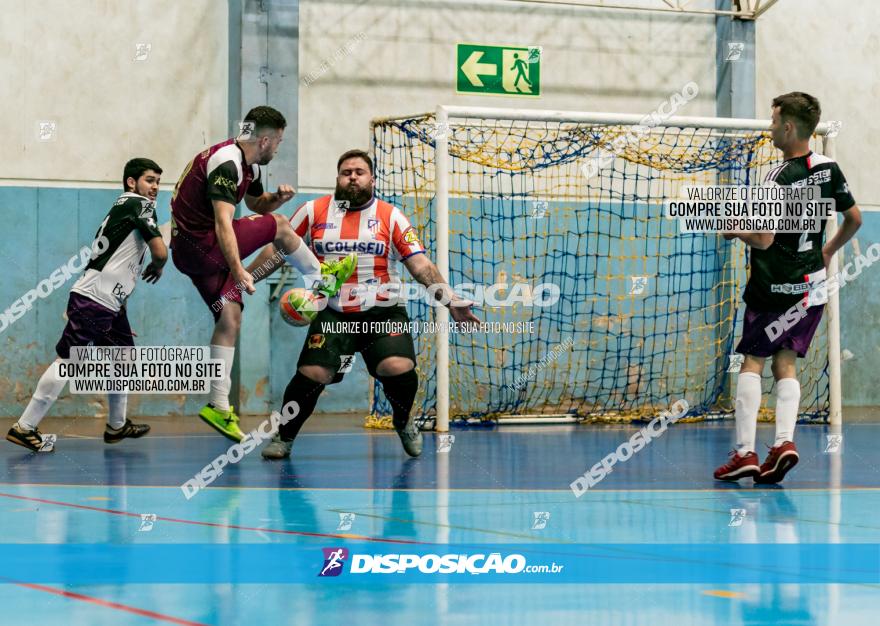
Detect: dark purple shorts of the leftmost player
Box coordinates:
(55, 292, 134, 359)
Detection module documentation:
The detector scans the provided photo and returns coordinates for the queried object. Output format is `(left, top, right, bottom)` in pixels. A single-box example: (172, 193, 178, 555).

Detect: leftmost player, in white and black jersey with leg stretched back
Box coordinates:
(6, 158, 168, 452)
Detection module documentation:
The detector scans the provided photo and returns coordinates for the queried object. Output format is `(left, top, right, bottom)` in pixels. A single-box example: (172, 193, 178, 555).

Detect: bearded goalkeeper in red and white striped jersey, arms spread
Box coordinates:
(251, 150, 479, 459)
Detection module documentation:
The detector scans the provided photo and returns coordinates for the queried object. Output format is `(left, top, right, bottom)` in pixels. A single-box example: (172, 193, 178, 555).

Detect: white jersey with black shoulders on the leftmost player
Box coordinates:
(71, 193, 161, 311)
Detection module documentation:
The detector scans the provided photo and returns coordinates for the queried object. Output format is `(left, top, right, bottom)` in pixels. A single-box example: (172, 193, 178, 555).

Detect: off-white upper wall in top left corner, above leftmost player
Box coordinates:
(0, 0, 228, 184)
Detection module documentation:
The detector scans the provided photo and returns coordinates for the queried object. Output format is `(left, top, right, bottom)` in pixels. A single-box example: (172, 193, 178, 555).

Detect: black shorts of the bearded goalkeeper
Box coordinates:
(296, 306, 416, 385)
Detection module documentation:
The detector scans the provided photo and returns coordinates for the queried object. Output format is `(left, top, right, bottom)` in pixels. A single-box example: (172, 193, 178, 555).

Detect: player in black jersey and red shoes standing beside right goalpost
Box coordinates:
(715, 92, 862, 483)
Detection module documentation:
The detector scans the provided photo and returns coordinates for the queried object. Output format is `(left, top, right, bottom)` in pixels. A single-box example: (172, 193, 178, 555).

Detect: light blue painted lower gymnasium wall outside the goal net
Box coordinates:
(0, 187, 880, 416)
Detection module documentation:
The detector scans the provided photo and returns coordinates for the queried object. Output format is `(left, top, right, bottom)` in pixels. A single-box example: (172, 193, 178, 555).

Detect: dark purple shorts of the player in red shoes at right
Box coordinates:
(736, 305, 825, 358)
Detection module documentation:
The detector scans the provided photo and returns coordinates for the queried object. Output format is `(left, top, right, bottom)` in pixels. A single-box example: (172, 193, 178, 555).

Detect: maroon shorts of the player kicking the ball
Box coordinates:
(171, 214, 278, 321)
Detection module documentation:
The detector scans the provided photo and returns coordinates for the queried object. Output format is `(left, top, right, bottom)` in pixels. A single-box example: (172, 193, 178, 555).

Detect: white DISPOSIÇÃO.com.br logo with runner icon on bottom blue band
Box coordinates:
(318, 548, 565, 577)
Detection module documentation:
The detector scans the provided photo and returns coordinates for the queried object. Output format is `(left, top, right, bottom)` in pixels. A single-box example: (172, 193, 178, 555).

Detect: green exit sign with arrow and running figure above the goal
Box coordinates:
(455, 43, 541, 97)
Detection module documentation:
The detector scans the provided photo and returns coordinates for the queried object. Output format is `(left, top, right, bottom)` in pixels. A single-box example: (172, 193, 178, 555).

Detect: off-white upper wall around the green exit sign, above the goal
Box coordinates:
(298, 0, 715, 188)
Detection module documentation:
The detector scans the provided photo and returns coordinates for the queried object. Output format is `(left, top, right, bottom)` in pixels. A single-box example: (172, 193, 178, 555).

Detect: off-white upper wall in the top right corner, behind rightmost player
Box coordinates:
(756, 0, 880, 208)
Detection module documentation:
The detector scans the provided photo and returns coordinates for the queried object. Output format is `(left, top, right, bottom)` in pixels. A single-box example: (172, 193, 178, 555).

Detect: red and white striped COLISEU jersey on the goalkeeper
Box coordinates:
(290, 195, 425, 313)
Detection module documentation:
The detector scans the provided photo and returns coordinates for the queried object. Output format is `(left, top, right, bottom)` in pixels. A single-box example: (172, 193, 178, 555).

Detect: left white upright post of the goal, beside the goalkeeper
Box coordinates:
(434, 106, 449, 432)
